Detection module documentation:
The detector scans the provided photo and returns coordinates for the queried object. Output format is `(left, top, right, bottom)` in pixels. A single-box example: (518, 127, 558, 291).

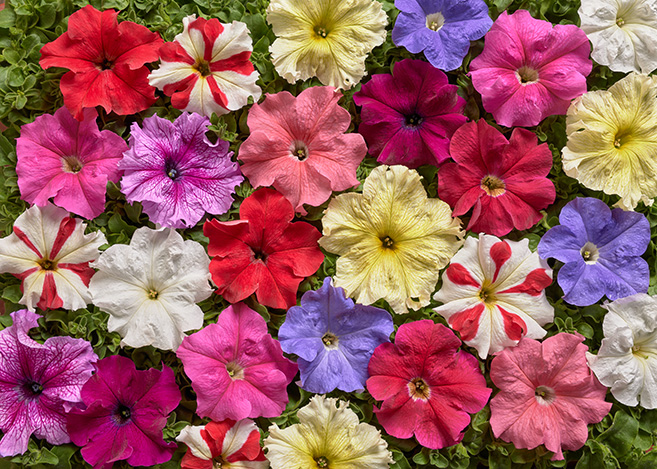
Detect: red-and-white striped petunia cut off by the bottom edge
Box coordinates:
(176, 419, 269, 469)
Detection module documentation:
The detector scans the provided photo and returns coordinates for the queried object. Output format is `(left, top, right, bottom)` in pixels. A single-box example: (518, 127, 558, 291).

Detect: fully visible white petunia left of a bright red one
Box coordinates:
(89, 227, 212, 350)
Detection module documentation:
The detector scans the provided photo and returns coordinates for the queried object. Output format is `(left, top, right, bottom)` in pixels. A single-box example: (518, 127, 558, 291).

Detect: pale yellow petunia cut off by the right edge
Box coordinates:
(563, 73, 657, 209)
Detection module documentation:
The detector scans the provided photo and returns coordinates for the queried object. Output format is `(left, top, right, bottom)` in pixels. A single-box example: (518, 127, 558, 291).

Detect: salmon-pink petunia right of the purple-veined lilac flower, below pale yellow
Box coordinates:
(239, 86, 367, 215)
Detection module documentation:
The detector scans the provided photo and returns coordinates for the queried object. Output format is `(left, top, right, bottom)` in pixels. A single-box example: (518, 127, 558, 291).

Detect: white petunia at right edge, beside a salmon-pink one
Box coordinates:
(586, 293, 657, 409)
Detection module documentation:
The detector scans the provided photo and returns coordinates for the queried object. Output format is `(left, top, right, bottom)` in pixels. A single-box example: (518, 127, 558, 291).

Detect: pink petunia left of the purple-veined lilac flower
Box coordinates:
(16, 107, 128, 220)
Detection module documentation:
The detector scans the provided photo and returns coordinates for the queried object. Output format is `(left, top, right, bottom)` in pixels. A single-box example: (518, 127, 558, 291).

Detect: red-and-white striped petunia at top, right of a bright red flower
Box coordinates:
(148, 15, 262, 117)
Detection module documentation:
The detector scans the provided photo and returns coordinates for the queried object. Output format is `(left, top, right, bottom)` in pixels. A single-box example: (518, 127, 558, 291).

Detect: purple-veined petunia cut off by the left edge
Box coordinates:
(0, 309, 98, 457)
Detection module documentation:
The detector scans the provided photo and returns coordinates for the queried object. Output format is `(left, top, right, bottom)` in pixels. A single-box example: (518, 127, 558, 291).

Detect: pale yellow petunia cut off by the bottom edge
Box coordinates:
(264, 396, 393, 469)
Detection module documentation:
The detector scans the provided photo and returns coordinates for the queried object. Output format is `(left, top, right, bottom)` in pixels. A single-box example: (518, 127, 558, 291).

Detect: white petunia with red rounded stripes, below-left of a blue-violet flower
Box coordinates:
(434, 234, 554, 358)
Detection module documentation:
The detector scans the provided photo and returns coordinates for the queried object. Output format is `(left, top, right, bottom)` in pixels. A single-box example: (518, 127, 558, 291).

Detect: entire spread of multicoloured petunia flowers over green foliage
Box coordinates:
(0, 0, 657, 469)
